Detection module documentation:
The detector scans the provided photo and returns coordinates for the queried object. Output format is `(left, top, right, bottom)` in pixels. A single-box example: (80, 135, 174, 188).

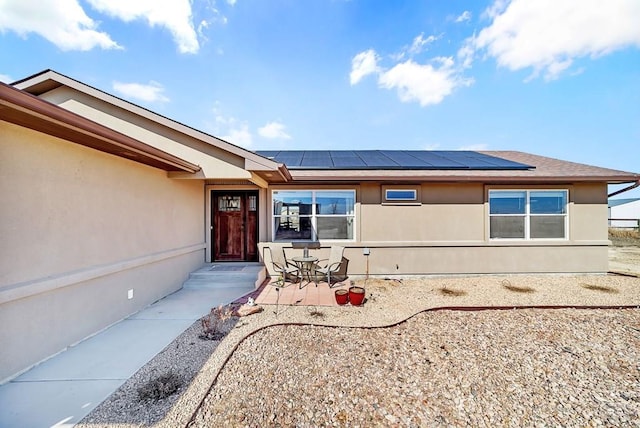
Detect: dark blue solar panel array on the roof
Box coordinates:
(257, 150, 534, 170)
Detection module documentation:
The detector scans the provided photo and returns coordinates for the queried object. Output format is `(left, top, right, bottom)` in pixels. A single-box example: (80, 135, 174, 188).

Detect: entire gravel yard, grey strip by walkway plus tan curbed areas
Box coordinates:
(79, 275, 640, 428)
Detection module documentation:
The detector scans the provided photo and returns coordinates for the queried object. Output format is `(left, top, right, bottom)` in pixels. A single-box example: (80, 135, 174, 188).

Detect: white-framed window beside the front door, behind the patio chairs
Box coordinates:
(273, 190, 356, 241)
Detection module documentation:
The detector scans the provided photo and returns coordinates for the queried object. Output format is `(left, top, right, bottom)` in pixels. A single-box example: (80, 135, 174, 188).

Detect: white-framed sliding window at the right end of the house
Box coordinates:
(489, 190, 568, 239)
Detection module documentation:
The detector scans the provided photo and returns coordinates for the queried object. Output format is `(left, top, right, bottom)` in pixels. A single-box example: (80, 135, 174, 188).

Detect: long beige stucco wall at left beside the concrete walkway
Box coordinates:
(0, 122, 204, 381)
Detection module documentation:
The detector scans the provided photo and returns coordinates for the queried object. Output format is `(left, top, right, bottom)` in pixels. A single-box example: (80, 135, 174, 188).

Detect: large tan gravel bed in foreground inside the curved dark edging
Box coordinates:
(192, 309, 640, 427)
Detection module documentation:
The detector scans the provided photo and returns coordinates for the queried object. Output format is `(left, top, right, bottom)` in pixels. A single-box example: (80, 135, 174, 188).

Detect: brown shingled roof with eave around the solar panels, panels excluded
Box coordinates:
(278, 151, 640, 184)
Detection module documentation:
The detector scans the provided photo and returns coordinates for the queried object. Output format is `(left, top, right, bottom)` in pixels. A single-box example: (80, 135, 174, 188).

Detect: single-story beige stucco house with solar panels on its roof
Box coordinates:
(0, 70, 640, 381)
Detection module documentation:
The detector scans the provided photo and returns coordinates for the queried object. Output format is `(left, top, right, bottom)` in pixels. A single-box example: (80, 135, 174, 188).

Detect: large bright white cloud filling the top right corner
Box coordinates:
(468, 0, 640, 80)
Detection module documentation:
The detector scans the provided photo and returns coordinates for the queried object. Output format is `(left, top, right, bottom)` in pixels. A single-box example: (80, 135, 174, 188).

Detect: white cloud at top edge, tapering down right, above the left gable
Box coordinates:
(87, 0, 200, 53)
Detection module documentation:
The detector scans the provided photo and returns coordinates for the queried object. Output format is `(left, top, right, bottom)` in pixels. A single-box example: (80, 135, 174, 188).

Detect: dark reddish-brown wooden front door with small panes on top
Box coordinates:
(211, 191, 258, 261)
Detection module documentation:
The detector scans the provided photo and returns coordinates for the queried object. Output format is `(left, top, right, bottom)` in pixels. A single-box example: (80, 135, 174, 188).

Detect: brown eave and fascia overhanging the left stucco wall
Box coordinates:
(0, 83, 200, 173)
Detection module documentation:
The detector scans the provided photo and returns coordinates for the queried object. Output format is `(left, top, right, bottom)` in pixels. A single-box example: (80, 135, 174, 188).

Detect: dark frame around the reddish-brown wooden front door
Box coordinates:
(211, 190, 261, 263)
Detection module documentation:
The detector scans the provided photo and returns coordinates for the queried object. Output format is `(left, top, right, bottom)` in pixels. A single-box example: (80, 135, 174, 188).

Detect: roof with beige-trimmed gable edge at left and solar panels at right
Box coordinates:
(8, 70, 640, 187)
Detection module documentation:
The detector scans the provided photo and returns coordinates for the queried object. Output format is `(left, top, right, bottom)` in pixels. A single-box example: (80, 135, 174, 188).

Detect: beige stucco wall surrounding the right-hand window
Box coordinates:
(263, 183, 608, 275)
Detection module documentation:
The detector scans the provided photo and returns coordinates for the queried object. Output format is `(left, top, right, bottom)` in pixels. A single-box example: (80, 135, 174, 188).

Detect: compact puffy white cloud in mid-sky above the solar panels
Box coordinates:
(378, 58, 473, 107)
